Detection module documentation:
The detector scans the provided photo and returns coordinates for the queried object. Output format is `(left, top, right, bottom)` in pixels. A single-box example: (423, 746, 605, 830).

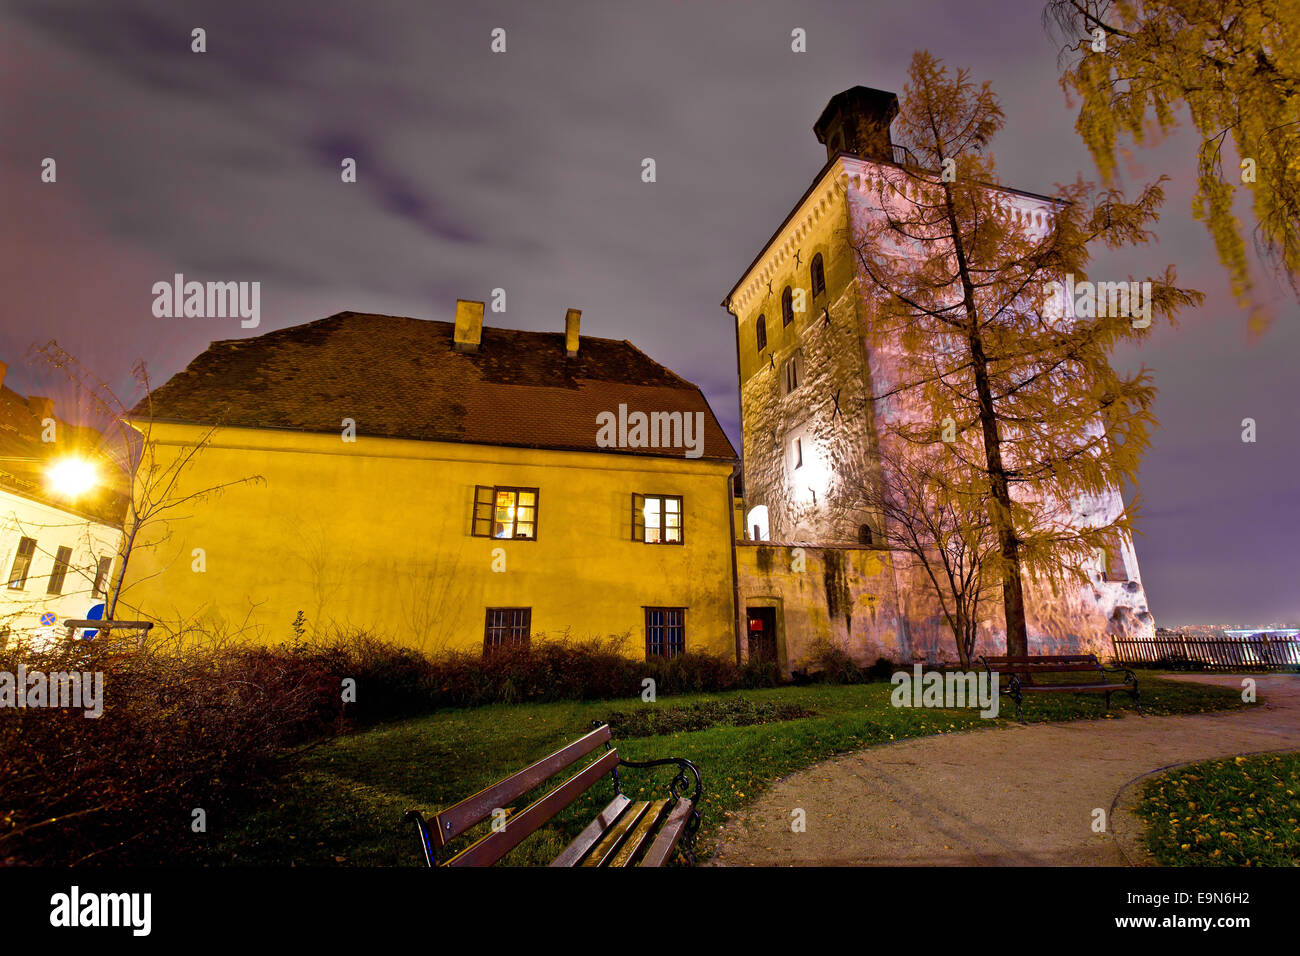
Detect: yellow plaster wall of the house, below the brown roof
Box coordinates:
(124, 425, 735, 657)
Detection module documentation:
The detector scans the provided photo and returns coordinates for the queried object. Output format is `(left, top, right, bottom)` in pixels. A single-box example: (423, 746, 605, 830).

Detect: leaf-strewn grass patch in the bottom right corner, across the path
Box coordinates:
(1136, 753, 1300, 866)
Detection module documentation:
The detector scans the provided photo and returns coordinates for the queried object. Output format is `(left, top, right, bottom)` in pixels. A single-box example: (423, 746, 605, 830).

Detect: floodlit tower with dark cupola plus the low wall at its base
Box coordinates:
(723, 87, 1154, 661)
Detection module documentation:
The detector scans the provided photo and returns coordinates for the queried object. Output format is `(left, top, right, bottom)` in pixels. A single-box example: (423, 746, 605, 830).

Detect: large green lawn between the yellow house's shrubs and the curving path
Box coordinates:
(200, 674, 1244, 866)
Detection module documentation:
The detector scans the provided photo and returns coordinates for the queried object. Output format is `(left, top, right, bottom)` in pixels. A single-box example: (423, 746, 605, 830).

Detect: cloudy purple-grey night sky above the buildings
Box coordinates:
(0, 0, 1300, 626)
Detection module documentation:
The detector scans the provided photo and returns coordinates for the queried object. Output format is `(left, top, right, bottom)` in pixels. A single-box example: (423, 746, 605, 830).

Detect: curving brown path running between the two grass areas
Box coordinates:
(711, 675, 1300, 866)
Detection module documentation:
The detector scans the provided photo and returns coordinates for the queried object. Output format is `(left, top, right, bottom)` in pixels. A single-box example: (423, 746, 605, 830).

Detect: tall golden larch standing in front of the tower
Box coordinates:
(853, 52, 1200, 654)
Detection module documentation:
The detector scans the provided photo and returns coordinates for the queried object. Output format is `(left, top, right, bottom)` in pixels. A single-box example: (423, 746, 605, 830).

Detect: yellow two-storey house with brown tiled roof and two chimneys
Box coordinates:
(122, 302, 736, 656)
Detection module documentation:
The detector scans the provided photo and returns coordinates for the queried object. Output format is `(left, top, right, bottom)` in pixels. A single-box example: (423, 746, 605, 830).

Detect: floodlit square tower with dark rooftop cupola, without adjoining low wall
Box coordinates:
(722, 86, 1154, 653)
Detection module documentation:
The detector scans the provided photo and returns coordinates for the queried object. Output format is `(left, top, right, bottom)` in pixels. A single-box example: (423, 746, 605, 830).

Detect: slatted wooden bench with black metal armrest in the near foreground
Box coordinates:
(406, 724, 702, 866)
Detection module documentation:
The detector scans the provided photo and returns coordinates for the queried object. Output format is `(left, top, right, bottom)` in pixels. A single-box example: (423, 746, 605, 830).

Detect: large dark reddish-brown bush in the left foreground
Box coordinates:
(0, 637, 343, 865)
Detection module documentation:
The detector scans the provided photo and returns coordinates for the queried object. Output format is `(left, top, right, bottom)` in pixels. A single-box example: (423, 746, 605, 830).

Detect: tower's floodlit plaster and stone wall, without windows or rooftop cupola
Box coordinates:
(729, 157, 1154, 659)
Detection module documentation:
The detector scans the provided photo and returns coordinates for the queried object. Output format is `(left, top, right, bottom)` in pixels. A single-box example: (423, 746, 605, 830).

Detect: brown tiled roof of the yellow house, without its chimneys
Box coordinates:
(133, 312, 737, 460)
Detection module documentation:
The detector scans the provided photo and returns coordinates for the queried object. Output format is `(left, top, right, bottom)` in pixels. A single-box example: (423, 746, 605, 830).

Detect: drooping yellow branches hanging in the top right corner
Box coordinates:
(1044, 0, 1300, 332)
